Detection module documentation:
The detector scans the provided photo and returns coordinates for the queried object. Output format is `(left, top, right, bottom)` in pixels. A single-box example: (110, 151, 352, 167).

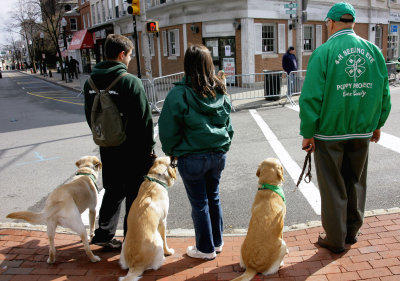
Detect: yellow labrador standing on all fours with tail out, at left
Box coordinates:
(7, 156, 101, 263)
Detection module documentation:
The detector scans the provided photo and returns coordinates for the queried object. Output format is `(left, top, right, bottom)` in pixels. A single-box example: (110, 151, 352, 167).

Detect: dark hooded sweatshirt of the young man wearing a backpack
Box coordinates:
(84, 61, 155, 155)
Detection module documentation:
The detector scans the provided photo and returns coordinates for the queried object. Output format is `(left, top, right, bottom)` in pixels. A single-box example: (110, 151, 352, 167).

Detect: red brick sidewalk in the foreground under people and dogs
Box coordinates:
(0, 209, 400, 281)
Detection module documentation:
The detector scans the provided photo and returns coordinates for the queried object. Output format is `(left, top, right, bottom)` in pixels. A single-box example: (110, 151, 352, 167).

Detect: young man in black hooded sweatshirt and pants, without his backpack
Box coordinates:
(84, 34, 155, 249)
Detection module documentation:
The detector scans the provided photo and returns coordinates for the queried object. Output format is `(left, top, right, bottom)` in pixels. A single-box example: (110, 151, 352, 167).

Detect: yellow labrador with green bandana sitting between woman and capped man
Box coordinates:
(234, 158, 288, 281)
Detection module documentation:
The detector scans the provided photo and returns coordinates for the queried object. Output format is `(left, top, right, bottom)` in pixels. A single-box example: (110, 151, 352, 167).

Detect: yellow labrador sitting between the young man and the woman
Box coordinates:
(119, 157, 176, 281)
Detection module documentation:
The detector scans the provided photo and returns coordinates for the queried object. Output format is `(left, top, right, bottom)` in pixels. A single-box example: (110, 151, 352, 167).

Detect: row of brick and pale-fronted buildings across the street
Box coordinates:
(64, 0, 400, 77)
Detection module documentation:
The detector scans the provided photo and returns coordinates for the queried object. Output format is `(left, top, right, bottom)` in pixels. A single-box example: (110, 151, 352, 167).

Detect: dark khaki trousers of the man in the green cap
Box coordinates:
(314, 139, 370, 247)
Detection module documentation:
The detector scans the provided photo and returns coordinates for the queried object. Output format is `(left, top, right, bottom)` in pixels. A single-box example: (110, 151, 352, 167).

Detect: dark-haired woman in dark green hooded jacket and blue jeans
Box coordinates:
(158, 45, 233, 259)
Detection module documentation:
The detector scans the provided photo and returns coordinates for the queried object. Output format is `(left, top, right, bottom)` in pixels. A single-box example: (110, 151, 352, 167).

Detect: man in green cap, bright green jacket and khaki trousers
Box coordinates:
(300, 2, 391, 253)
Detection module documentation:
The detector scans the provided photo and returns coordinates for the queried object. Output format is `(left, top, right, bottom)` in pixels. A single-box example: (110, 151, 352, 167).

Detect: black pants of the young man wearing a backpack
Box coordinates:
(92, 147, 153, 242)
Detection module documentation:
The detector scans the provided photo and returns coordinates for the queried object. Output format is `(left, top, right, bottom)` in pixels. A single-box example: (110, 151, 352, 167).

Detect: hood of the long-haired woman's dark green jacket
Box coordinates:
(174, 77, 230, 115)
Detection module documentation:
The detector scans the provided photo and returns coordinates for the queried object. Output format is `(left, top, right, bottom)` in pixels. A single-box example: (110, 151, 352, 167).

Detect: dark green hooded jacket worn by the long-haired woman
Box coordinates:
(158, 78, 233, 157)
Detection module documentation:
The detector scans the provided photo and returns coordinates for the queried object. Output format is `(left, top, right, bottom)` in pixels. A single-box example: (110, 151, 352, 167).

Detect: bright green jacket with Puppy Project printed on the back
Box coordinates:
(299, 29, 391, 141)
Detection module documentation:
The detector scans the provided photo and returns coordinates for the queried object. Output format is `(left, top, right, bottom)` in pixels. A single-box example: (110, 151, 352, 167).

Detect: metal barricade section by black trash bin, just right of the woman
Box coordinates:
(227, 71, 287, 109)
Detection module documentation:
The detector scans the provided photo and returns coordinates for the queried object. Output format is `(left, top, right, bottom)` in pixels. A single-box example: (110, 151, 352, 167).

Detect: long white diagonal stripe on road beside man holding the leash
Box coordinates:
(249, 109, 321, 215)
